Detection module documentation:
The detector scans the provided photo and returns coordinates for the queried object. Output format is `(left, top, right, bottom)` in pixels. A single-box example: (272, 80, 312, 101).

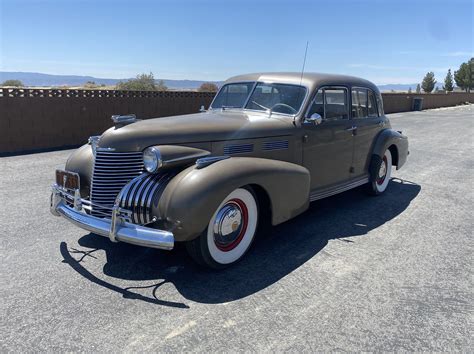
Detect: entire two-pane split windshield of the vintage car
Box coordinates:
(211, 82, 306, 114)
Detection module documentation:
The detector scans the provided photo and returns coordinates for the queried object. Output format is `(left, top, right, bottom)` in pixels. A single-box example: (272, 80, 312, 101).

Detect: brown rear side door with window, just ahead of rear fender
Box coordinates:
(351, 87, 384, 177)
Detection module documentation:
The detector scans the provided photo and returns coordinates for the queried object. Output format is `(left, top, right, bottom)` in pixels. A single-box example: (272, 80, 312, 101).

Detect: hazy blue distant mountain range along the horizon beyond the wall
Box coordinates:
(0, 71, 417, 91)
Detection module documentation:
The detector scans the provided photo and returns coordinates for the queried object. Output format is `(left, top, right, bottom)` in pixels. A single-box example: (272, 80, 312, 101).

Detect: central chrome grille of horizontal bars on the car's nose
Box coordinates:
(90, 150, 143, 217)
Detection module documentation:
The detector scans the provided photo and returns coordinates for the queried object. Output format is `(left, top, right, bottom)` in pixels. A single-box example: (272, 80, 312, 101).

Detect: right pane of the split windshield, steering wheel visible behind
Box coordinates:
(245, 83, 306, 114)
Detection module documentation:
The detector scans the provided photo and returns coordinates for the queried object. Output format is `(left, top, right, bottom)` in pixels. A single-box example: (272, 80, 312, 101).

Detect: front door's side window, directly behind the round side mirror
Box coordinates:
(308, 88, 349, 120)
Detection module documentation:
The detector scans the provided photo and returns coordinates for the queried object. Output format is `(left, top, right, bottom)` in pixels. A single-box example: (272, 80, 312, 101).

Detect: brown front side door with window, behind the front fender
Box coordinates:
(302, 86, 353, 190)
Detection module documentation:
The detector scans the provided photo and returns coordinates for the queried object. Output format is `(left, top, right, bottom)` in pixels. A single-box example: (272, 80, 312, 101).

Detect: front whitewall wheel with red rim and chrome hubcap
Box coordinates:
(186, 188, 258, 269)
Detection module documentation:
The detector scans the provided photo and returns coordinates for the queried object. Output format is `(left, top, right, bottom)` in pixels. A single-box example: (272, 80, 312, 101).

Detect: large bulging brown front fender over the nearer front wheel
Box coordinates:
(154, 157, 310, 241)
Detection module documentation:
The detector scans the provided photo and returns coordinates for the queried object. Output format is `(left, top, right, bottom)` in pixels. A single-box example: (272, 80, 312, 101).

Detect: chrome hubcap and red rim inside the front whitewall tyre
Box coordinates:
(213, 199, 248, 252)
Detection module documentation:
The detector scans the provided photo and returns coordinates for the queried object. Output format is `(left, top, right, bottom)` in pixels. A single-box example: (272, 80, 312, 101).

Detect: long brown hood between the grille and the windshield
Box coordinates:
(98, 111, 294, 151)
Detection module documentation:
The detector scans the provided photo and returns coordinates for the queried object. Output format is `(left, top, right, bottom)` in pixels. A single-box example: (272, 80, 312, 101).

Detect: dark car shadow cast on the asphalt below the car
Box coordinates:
(60, 179, 421, 308)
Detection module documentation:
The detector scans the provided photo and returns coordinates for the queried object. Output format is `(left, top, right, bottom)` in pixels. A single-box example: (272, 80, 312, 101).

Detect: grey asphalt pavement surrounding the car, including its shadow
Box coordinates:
(0, 105, 474, 352)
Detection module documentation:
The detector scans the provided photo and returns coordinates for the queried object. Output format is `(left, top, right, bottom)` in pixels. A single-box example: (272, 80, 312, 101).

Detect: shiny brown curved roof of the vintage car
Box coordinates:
(225, 72, 379, 92)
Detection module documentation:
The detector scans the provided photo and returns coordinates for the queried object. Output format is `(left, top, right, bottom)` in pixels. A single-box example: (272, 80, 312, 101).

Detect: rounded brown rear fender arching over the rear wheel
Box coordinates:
(372, 129, 408, 170)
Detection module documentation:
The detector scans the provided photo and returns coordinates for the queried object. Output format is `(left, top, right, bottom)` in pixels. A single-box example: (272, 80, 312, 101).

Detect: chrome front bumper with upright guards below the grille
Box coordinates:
(50, 184, 174, 250)
